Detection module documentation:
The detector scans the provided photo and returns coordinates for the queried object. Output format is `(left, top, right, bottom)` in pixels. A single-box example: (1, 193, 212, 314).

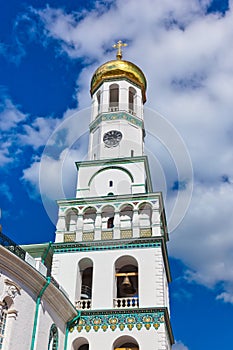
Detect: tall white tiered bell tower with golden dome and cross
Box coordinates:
(52, 41, 173, 350)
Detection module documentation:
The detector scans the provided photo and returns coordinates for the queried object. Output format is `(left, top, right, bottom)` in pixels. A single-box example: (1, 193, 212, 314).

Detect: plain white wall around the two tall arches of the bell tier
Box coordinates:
(53, 247, 168, 309)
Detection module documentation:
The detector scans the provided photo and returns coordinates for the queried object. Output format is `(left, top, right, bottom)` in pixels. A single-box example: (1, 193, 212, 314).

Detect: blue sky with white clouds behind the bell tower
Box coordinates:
(0, 0, 233, 350)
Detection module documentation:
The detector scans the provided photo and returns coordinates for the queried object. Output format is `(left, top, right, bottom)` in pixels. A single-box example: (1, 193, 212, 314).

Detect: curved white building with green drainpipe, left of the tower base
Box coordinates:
(0, 246, 77, 350)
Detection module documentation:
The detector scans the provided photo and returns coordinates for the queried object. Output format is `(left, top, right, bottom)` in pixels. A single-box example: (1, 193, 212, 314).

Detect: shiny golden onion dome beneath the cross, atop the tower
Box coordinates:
(91, 59, 146, 103)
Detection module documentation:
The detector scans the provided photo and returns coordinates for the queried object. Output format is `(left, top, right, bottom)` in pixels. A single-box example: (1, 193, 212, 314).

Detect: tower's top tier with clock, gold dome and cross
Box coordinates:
(89, 40, 146, 165)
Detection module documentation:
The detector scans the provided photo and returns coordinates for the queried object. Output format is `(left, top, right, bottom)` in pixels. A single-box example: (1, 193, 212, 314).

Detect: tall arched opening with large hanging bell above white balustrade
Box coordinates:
(114, 255, 139, 308)
